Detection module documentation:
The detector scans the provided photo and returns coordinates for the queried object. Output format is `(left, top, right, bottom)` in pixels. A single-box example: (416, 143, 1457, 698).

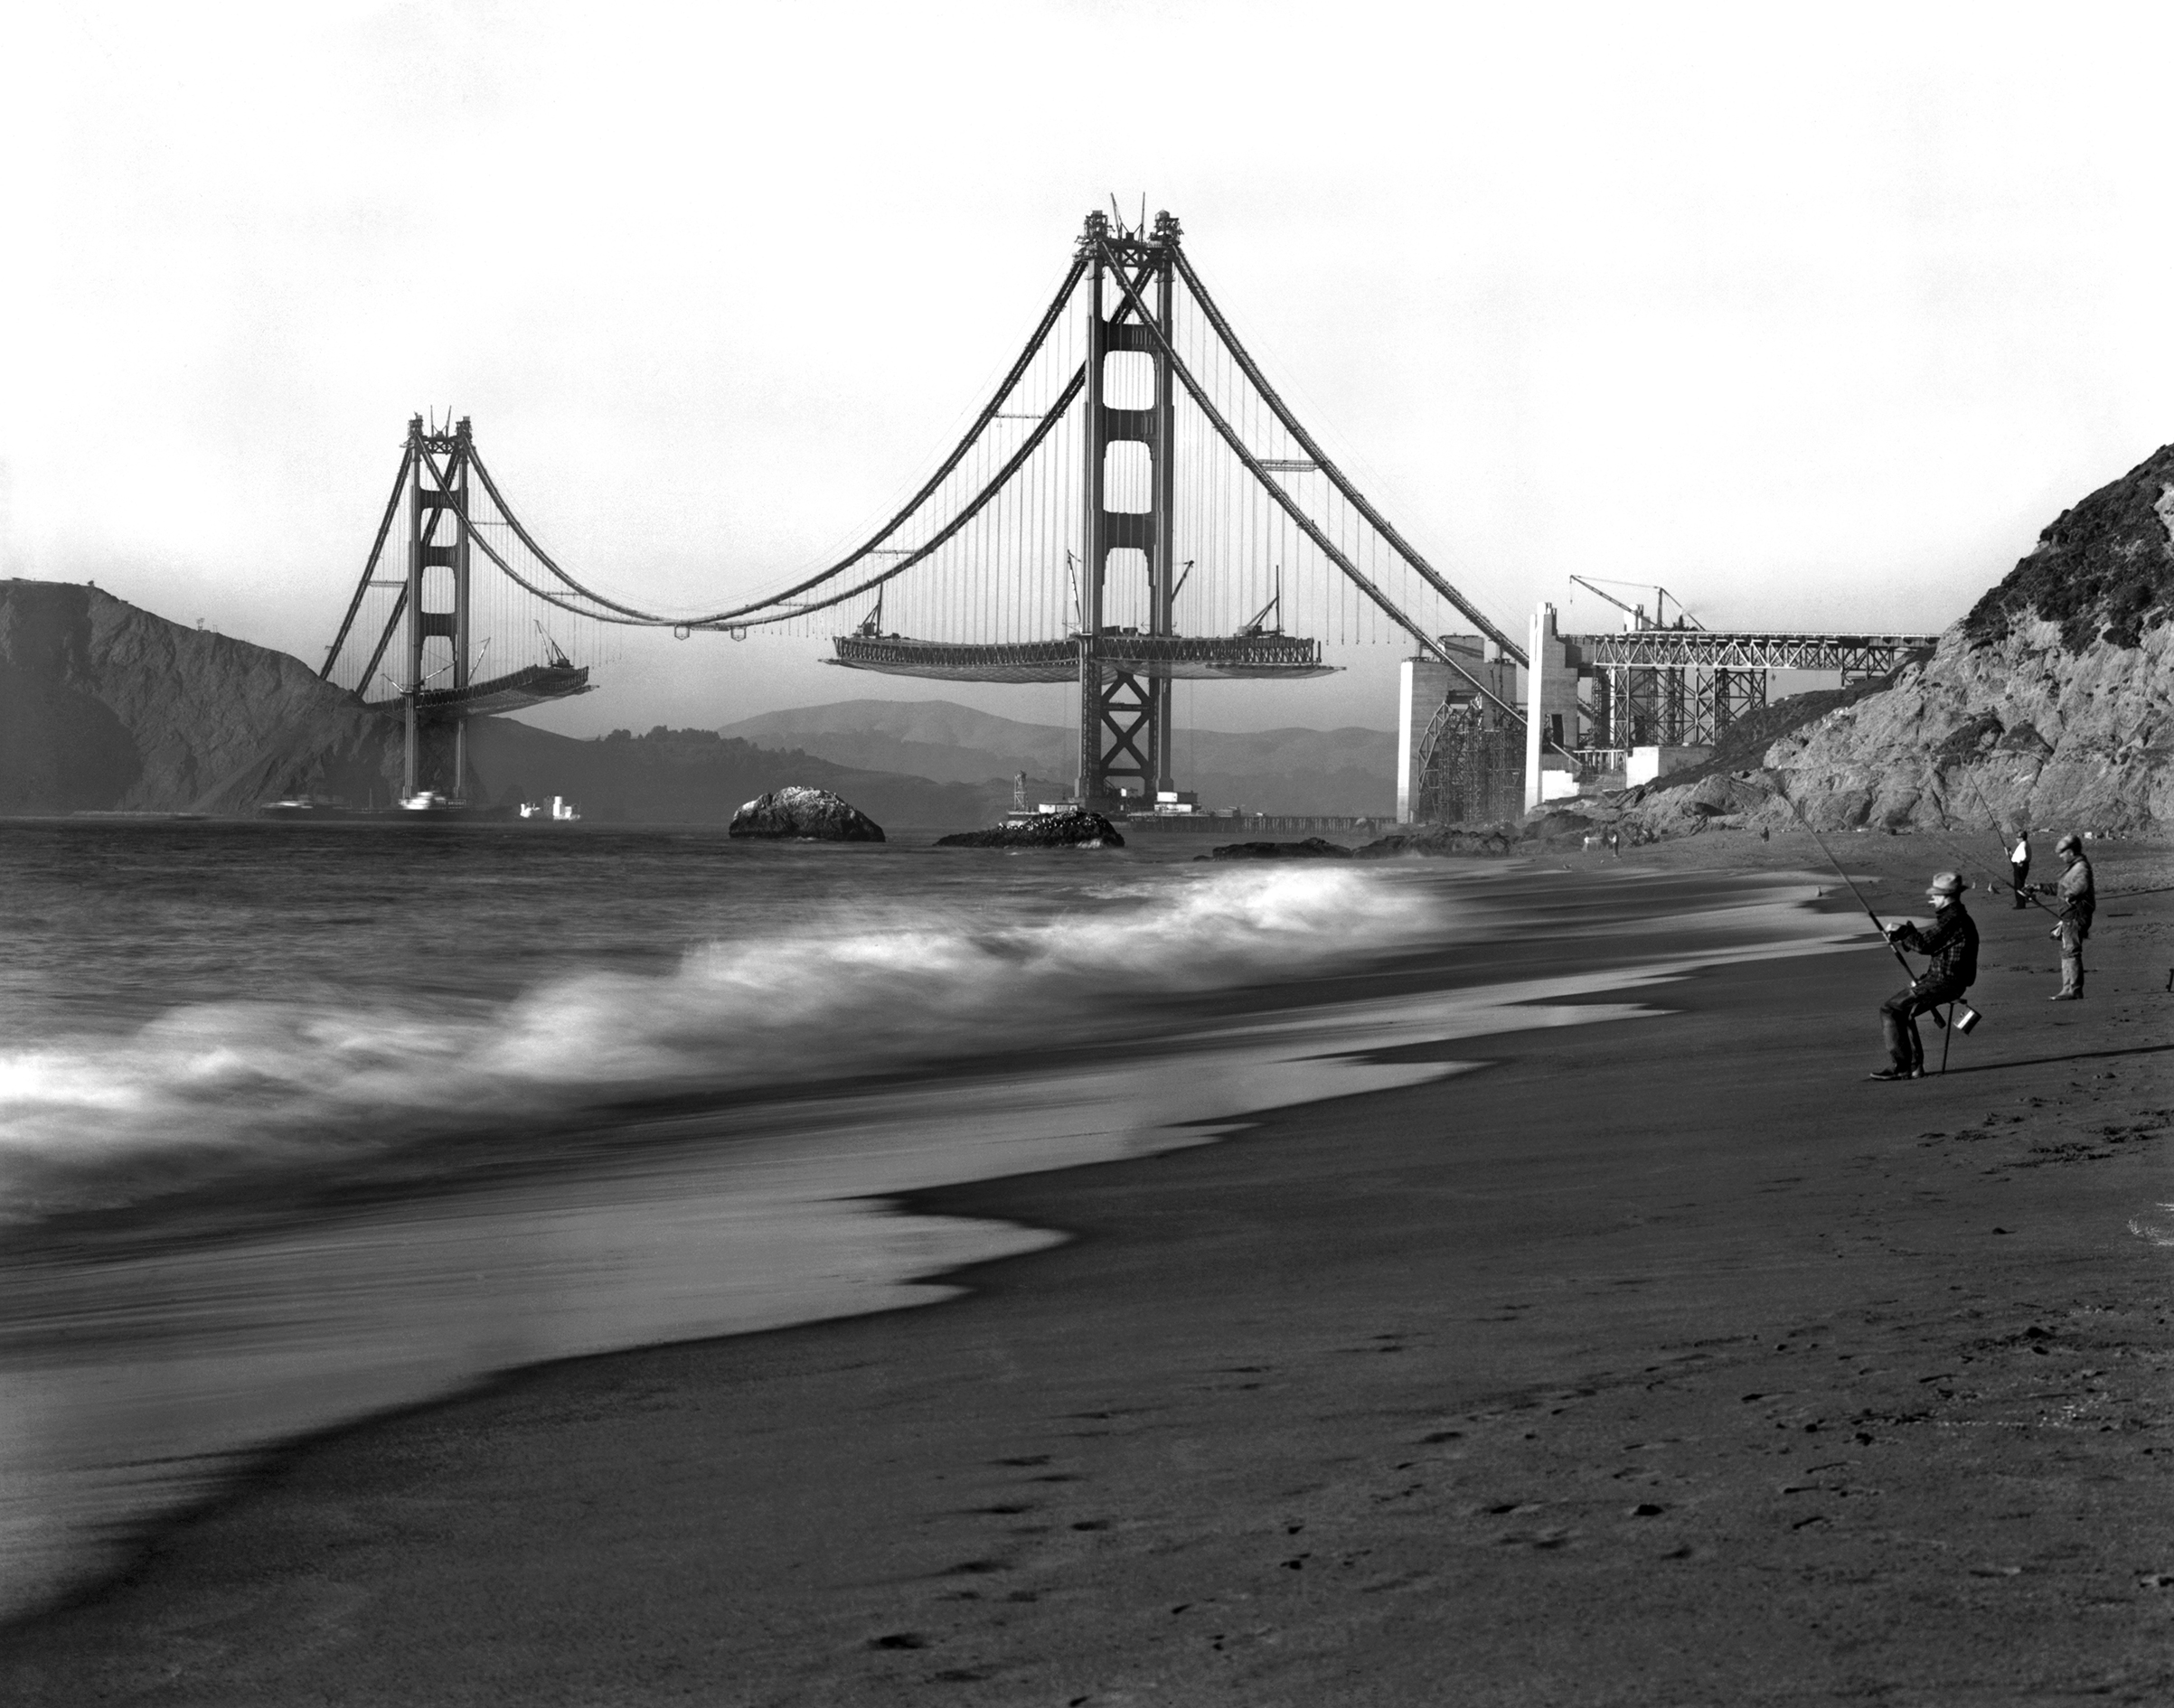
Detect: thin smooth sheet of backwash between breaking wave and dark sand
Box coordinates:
(0, 877, 1832, 1617)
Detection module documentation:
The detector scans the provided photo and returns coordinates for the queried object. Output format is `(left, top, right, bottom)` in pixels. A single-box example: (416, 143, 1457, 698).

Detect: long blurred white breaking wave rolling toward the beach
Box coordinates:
(0, 867, 1442, 1221)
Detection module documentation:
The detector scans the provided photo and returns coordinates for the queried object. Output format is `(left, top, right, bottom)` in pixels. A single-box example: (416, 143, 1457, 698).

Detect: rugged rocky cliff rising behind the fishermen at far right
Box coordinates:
(1626, 446, 2174, 834)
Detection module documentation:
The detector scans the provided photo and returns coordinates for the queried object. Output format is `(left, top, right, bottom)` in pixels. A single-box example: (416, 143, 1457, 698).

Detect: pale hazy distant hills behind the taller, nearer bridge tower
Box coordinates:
(720, 699, 1396, 815)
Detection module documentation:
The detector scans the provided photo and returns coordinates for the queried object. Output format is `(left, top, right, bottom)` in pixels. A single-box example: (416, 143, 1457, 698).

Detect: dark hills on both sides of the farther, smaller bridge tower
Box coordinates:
(0, 580, 1011, 831)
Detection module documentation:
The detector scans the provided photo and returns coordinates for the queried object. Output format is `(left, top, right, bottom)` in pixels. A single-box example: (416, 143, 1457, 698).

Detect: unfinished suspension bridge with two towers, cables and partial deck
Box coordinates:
(320, 213, 1933, 820)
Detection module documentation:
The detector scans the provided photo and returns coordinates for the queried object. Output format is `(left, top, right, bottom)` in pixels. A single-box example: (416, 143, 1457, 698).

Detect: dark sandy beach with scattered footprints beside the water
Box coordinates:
(0, 839, 2174, 1703)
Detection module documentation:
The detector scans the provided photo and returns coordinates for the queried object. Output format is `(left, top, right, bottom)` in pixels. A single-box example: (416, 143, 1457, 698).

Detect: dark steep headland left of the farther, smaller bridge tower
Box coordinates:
(0, 580, 400, 812)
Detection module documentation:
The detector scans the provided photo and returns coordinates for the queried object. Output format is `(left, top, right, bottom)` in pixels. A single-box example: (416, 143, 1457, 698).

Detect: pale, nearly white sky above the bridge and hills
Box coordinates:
(0, 0, 2174, 735)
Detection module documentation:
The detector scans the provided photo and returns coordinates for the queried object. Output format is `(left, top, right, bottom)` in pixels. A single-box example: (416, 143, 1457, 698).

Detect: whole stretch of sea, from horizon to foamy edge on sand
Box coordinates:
(0, 821, 1835, 1615)
